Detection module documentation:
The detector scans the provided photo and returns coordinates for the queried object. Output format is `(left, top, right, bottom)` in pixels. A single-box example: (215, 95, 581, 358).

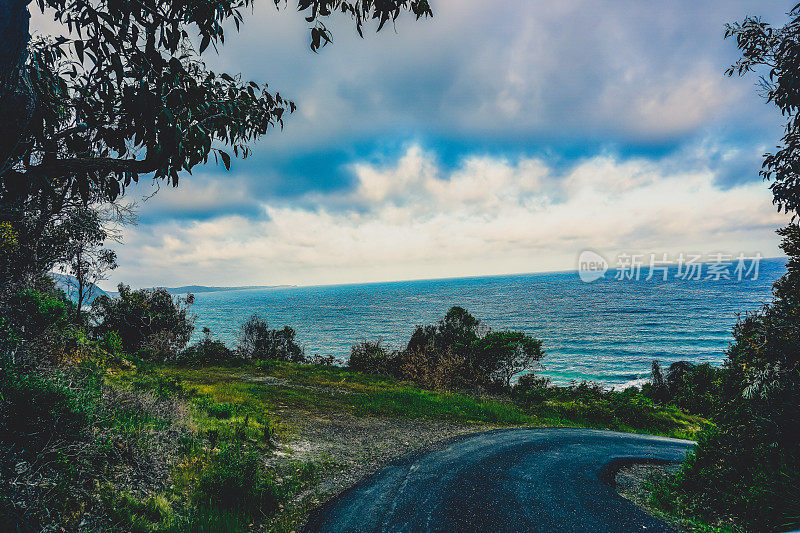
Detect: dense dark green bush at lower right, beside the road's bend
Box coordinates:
(653, 226, 800, 531)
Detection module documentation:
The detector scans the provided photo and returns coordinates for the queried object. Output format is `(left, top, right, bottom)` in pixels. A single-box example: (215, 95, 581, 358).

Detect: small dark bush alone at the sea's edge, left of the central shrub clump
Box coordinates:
(237, 314, 304, 363)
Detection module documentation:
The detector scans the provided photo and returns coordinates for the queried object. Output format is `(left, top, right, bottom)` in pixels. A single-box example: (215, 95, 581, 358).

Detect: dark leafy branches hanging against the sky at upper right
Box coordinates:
(725, 4, 800, 216)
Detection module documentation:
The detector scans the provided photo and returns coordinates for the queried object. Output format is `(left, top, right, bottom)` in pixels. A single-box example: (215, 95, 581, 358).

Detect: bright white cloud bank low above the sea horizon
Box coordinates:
(109, 146, 785, 285)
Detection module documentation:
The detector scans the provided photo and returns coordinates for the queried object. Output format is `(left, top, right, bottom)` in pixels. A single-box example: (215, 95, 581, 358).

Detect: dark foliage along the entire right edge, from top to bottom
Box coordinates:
(656, 9, 800, 531)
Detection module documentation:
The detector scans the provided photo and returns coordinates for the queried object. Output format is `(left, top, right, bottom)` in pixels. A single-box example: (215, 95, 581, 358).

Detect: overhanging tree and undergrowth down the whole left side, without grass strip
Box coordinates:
(0, 0, 431, 531)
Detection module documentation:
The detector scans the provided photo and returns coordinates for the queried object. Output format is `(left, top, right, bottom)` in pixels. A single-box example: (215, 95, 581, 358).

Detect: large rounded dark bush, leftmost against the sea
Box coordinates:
(92, 284, 194, 361)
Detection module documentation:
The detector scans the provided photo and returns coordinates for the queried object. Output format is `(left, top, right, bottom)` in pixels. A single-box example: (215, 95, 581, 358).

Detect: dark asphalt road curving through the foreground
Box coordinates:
(307, 428, 693, 533)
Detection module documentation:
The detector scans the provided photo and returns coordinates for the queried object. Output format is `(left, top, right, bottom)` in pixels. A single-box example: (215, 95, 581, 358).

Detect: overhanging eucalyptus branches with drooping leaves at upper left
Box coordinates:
(0, 0, 431, 256)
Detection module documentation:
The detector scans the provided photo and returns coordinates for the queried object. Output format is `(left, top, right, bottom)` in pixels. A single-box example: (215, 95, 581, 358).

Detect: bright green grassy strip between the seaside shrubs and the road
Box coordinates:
(111, 363, 708, 438)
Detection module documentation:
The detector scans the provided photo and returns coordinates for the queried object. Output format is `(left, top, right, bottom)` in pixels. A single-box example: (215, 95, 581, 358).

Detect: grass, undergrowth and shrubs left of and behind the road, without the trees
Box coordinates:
(0, 272, 708, 531)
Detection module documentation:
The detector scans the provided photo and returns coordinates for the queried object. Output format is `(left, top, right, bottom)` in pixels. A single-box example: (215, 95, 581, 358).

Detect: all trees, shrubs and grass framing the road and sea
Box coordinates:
(0, 0, 800, 531)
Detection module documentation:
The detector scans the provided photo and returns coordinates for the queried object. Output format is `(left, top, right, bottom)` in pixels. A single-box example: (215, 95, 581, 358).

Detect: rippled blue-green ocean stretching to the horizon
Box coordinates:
(184, 259, 785, 387)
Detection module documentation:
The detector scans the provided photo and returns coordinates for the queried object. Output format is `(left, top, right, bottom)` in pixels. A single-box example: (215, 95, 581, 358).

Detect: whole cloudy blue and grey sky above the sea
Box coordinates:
(32, 0, 791, 288)
